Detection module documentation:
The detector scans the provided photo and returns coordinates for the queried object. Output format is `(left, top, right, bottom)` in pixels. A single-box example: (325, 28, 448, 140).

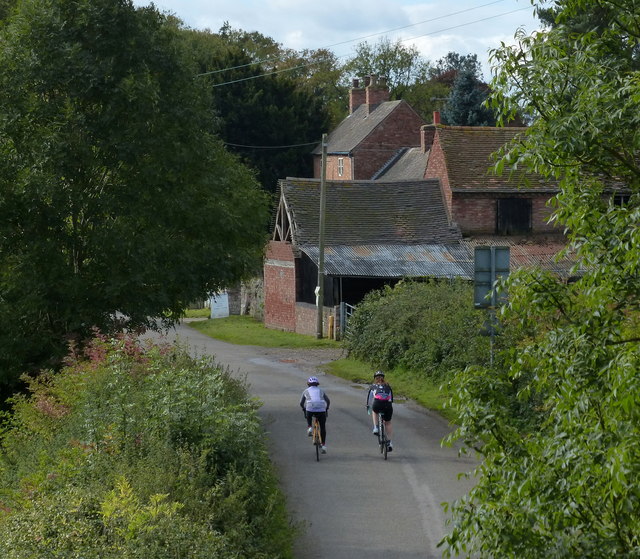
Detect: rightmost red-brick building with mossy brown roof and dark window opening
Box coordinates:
(422, 120, 570, 275)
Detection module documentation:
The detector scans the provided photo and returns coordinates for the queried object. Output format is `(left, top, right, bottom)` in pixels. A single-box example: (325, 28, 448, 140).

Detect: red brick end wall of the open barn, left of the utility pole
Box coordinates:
(264, 241, 296, 332)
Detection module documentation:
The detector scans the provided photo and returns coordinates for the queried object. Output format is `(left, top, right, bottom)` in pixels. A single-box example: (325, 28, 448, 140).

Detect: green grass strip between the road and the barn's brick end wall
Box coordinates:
(189, 315, 340, 348)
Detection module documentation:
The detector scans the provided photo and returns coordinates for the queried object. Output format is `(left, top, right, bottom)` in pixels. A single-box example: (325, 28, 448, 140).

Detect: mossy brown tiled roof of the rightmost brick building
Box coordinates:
(437, 126, 556, 190)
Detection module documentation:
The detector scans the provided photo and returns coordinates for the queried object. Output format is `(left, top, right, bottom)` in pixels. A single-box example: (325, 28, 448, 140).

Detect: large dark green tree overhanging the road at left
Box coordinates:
(0, 0, 268, 396)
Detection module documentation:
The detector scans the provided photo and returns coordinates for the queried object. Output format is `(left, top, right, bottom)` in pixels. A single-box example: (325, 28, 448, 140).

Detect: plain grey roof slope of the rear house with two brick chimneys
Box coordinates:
(313, 101, 406, 155)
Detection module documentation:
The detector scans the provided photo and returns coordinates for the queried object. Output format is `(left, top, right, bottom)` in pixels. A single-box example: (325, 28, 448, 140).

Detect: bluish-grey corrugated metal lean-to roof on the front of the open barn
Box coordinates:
(299, 244, 473, 279)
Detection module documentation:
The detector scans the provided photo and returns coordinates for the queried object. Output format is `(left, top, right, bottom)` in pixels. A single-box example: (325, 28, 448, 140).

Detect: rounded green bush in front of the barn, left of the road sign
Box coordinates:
(346, 280, 490, 380)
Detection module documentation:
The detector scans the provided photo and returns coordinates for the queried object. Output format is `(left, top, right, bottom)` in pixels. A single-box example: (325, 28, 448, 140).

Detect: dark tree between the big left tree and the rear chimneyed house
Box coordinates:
(181, 31, 329, 192)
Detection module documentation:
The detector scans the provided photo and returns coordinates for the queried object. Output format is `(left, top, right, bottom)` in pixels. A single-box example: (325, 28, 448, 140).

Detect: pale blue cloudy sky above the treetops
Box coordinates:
(133, 0, 539, 79)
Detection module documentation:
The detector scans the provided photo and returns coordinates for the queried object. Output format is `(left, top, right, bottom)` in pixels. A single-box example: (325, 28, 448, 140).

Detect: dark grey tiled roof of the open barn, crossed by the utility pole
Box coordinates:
(279, 178, 461, 247)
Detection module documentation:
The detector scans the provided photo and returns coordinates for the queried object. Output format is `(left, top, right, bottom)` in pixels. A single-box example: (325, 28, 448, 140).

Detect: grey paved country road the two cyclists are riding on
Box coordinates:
(145, 325, 474, 559)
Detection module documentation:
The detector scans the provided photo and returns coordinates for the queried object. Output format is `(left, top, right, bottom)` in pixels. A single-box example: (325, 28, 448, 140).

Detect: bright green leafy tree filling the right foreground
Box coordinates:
(446, 0, 640, 559)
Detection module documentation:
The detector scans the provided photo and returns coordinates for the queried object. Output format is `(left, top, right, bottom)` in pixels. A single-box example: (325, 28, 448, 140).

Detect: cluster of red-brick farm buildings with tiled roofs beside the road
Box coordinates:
(264, 78, 570, 335)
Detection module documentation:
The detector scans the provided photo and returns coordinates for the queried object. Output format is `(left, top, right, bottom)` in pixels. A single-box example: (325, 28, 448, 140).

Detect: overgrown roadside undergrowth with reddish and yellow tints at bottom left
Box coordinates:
(0, 337, 294, 559)
